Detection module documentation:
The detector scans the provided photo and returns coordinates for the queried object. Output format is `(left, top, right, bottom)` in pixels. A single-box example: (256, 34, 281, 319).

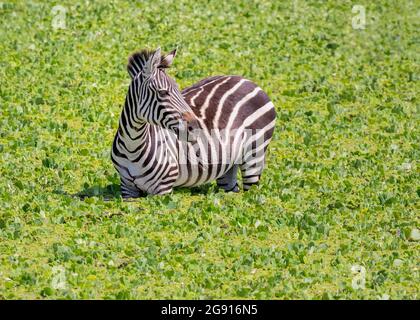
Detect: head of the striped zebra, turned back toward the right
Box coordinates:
(127, 48, 198, 141)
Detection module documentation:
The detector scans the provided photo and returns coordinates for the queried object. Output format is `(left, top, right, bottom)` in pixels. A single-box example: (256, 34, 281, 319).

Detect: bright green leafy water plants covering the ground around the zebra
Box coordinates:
(0, 0, 420, 299)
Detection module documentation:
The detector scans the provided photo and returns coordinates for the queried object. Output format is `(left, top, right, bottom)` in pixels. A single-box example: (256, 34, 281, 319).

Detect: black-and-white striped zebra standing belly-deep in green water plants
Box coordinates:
(111, 48, 276, 198)
